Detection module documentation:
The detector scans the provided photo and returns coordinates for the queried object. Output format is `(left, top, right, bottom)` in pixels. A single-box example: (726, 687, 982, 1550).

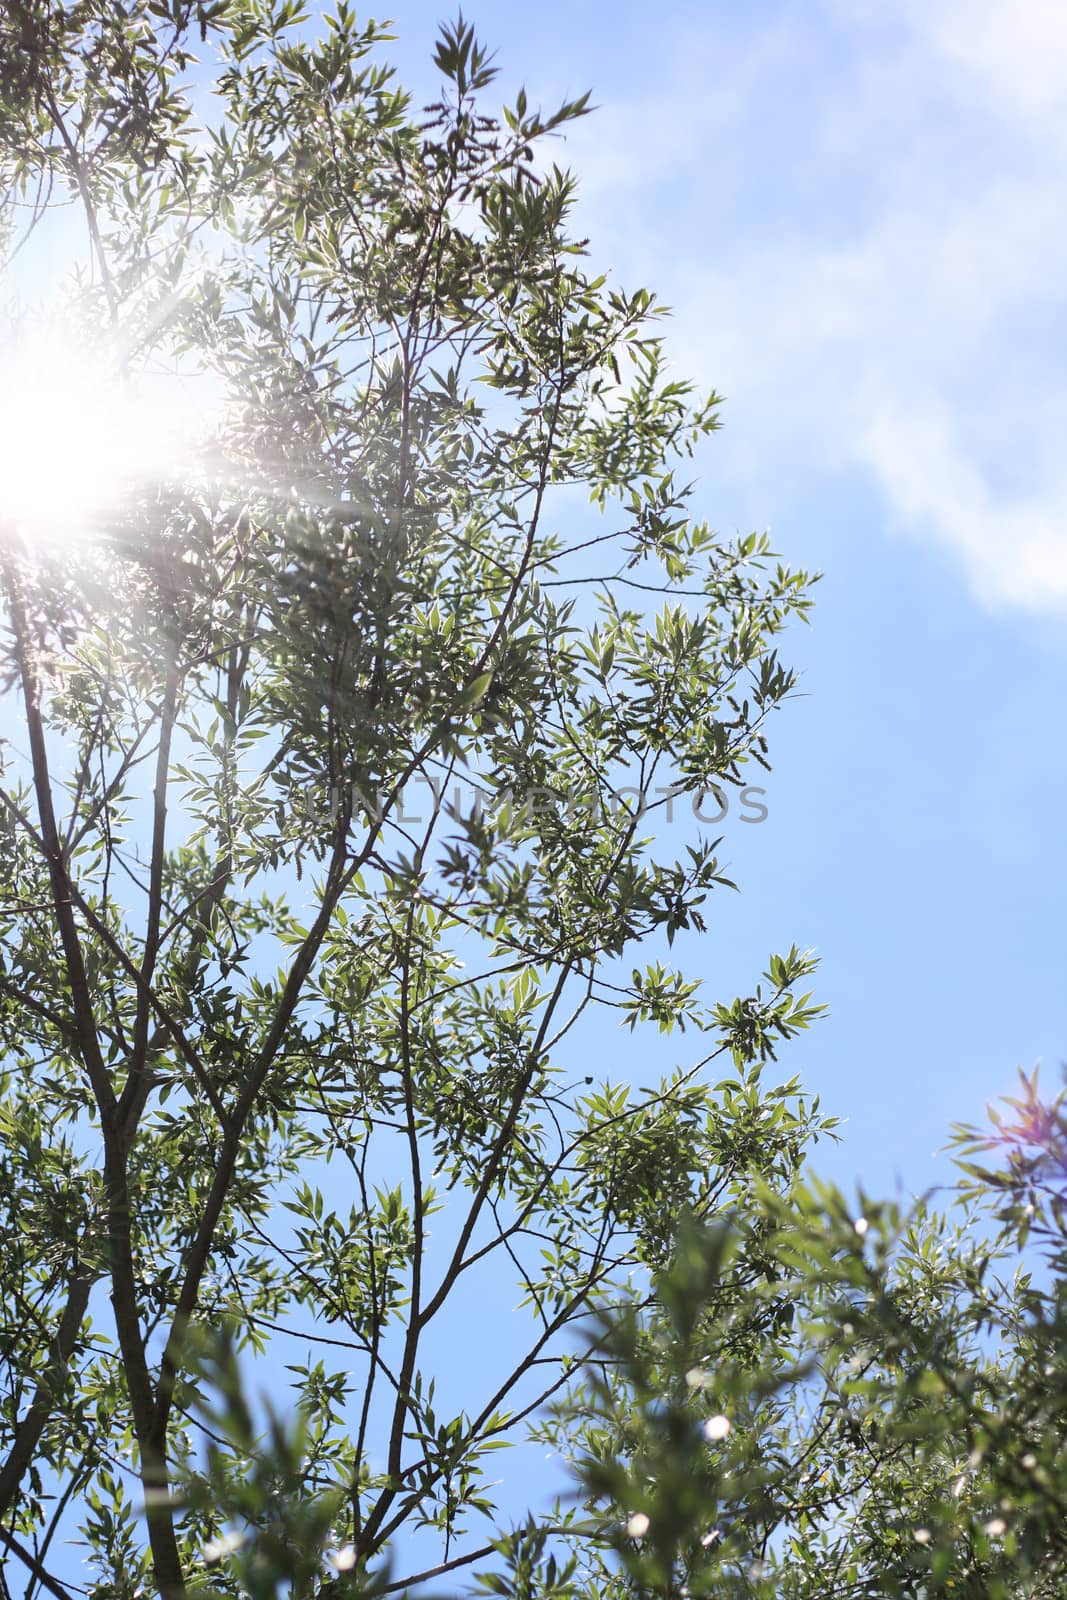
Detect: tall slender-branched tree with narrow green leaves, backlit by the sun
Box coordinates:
(0, 0, 825, 1600)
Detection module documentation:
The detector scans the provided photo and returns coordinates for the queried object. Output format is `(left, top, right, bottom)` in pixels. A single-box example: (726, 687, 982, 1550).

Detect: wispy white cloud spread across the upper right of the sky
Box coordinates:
(574, 0, 1067, 611)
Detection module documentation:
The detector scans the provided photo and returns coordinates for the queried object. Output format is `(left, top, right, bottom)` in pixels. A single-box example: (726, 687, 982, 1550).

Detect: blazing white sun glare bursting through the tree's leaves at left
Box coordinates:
(0, 330, 203, 549)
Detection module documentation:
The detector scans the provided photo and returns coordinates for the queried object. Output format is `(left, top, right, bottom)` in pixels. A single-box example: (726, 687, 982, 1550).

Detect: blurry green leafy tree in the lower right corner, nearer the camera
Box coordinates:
(556, 1075, 1067, 1600)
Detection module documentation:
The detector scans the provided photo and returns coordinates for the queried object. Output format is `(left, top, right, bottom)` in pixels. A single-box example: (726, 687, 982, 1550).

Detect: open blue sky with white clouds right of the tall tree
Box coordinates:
(379, 0, 1067, 1194)
